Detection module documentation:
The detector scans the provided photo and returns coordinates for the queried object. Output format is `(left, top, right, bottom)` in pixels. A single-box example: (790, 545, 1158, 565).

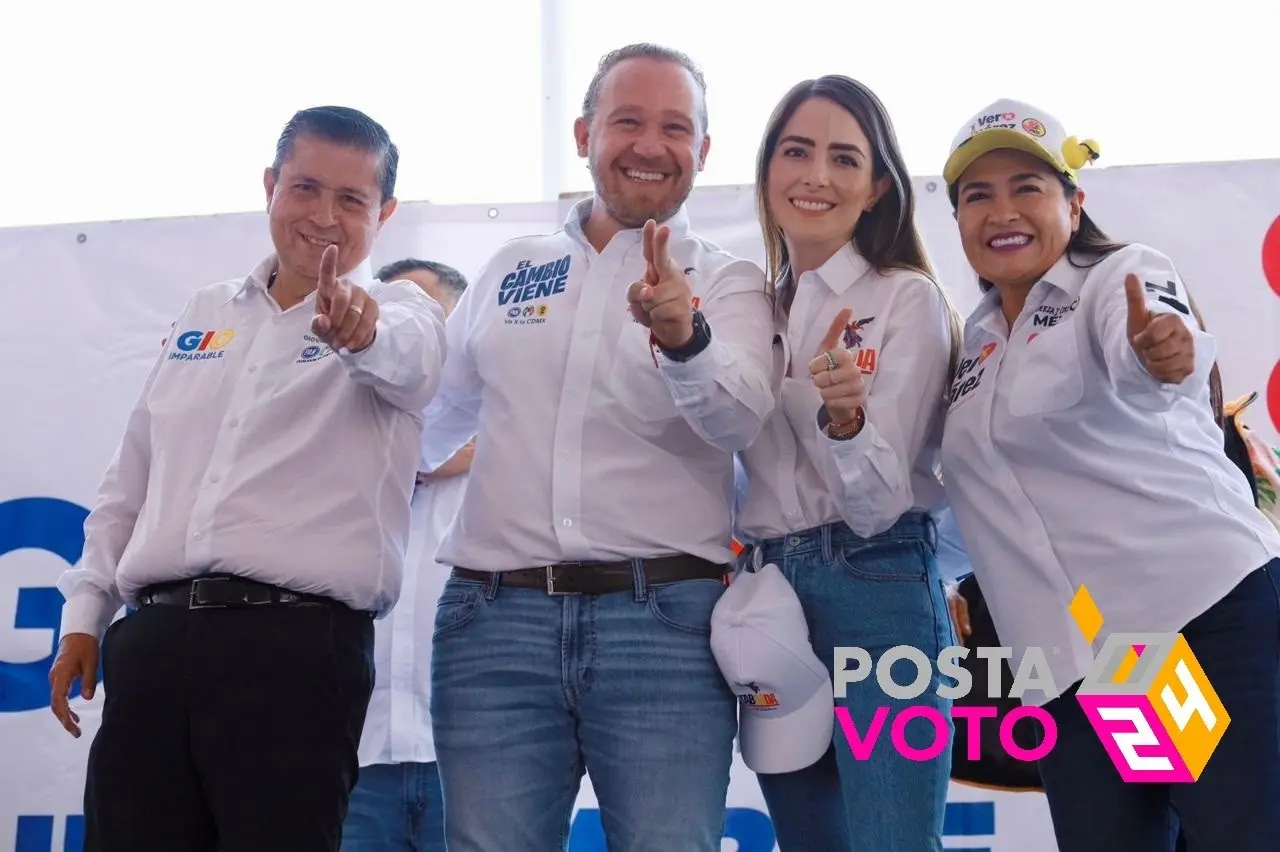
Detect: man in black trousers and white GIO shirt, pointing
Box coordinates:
(50, 106, 445, 852)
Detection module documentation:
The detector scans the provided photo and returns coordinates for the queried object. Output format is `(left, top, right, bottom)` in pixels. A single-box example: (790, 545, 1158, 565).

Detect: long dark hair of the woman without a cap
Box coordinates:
(755, 74, 963, 375)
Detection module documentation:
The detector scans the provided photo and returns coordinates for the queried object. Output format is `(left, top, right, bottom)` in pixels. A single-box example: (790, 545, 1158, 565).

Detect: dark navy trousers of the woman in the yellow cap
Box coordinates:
(1039, 559, 1280, 852)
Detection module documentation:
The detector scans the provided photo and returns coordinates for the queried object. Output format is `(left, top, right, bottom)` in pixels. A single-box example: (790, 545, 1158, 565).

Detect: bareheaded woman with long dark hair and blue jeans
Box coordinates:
(739, 75, 959, 852)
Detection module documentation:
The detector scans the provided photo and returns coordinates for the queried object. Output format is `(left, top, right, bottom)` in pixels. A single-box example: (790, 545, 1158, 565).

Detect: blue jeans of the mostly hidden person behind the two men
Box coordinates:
(342, 764, 444, 852)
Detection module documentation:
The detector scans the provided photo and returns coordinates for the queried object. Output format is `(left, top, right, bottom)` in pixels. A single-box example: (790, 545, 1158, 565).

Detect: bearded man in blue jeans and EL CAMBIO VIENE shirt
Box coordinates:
(424, 45, 774, 852)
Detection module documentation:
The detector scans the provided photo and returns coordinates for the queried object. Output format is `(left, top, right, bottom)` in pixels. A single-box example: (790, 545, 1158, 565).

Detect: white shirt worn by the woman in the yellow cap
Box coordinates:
(942, 240, 1280, 704)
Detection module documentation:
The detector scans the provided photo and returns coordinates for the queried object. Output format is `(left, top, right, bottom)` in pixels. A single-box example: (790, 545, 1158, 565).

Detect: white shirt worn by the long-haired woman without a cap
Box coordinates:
(739, 244, 952, 540)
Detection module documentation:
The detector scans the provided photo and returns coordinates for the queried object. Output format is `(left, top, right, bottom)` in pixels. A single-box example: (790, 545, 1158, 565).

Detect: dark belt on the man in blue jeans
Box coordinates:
(453, 555, 728, 595)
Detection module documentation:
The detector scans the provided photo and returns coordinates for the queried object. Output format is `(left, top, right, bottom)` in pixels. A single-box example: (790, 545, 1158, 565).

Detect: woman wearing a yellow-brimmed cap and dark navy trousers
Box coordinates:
(942, 95, 1280, 852)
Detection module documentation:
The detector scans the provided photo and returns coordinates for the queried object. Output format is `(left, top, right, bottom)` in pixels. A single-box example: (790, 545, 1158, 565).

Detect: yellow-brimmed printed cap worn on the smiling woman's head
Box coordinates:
(942, 99, 1100, 187)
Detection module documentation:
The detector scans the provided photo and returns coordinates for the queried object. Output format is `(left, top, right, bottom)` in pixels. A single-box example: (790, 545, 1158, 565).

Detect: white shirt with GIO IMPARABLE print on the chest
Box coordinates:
(58, 255, 445, 637)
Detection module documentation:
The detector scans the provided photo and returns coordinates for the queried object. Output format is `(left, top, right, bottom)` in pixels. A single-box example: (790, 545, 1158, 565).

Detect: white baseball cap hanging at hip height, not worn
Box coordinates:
(712, 564, 836, 774)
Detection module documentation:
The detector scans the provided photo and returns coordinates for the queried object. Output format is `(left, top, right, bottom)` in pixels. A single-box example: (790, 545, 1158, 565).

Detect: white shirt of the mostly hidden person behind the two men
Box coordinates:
(360, 473, 467, 766)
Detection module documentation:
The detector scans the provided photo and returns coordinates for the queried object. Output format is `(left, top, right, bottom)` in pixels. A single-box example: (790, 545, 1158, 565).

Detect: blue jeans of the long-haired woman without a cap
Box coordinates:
(756, 514, 957, 852)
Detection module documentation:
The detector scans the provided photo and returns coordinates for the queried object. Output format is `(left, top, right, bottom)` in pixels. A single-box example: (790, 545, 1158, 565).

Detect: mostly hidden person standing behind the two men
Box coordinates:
(342, 257, 472, 852)
